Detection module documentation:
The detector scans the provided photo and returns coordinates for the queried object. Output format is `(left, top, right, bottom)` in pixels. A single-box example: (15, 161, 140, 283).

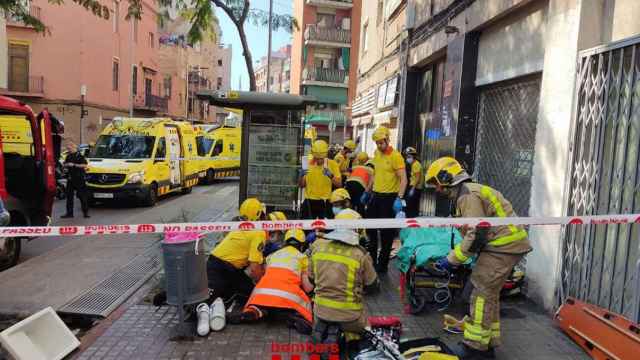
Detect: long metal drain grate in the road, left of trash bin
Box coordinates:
(58, 243, 161, 317)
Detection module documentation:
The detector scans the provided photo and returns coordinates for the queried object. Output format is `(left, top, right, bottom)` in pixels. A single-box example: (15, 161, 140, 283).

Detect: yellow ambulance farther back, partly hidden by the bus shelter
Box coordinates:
(196, 126, 242, 184)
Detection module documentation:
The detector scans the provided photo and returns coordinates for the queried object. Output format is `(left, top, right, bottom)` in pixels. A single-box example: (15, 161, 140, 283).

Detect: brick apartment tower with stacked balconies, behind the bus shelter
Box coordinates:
(291, 0, 362, 142)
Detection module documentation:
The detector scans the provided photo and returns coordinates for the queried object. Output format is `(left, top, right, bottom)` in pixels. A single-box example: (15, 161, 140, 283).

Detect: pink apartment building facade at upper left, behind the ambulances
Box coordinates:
(2, 0, 168, 142)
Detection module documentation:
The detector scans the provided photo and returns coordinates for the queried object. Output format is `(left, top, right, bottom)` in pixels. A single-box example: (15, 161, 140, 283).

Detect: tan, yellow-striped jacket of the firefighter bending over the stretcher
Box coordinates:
(449, 183, 531, 263)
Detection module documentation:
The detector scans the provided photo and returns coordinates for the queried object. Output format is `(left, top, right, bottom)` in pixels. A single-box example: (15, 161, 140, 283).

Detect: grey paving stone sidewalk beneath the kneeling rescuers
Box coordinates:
(74, 262, 589, 360)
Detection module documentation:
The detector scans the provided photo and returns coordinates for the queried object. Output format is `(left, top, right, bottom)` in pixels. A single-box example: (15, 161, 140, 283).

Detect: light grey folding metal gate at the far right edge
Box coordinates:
(558, 38, 640, 320)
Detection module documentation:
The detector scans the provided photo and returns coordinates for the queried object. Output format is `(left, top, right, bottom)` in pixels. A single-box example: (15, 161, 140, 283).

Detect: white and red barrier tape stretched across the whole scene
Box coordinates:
(0, 214, 640, 237)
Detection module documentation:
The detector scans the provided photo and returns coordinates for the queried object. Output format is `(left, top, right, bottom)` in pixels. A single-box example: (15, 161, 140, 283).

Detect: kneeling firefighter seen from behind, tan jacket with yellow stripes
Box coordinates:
(309, 209, 379, 356)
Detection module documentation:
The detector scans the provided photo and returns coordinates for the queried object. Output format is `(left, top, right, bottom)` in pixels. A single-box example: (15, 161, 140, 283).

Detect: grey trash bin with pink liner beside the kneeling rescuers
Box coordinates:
(162, 233, 209, 306)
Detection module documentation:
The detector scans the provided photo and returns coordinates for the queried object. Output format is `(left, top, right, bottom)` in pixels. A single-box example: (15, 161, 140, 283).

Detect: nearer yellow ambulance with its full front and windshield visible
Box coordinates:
(87, 118, 200, 206)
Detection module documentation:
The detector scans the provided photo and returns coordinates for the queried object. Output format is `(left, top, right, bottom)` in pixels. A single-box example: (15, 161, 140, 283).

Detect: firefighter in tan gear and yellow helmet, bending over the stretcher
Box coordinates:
(426, 157, 531, 360)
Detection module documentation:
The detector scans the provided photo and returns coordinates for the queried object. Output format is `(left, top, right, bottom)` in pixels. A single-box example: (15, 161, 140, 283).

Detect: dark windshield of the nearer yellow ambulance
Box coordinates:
(91, 135, 156, 159)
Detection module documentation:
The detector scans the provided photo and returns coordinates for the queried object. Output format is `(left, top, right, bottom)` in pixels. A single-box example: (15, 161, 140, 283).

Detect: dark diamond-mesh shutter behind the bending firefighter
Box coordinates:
(474, 76, 540, 216)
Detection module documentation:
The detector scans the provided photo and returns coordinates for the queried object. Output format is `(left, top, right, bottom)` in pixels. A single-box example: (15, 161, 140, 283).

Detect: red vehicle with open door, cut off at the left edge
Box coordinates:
(0, 96, 56, 270)
